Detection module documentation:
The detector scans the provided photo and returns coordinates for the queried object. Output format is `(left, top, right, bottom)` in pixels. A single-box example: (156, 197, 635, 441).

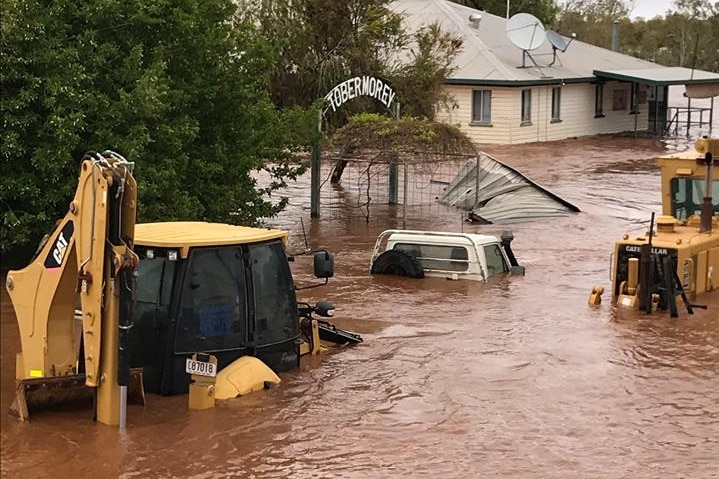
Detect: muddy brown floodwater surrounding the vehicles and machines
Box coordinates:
(0, 138, 719, 479)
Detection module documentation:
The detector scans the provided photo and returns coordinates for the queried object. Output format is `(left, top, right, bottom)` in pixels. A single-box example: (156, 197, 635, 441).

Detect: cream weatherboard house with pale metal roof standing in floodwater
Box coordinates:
(390, 0, 719, 144)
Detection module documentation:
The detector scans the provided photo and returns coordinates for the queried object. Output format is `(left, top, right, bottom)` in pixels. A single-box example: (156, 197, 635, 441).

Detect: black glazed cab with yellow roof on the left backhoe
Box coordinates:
(129, 222, 361, 395)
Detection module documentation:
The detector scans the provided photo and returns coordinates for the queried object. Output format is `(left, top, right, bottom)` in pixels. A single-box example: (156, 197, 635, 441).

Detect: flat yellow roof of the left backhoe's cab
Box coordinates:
(135, 221, 287, 258)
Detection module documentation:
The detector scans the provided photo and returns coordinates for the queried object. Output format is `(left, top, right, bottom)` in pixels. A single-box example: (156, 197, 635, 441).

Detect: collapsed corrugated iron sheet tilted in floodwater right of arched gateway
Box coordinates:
(439, 153, 579, 223)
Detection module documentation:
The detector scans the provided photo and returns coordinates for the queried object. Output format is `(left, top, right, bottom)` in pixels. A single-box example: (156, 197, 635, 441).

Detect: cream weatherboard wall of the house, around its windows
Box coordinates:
(437, 82, 647, 145)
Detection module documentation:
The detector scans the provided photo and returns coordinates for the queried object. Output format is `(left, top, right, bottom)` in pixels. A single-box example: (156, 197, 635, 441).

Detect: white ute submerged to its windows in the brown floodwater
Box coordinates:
(370, 230, 524, 281)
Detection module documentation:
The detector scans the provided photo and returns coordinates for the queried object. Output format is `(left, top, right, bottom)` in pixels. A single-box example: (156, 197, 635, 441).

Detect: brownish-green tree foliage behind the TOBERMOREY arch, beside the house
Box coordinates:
(244, 0, 461, 122)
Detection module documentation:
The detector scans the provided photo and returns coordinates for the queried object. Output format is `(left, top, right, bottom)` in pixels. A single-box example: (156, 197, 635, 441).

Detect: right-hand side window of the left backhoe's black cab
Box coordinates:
(249, 241, 299, 346)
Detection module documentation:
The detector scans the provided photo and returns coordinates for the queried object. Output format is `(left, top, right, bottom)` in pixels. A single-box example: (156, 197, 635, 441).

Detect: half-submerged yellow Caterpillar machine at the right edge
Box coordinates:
(589, 138, 719, 317)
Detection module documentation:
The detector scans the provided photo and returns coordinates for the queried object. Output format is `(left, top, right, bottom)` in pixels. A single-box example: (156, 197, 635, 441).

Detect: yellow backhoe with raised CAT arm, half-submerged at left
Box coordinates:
(6, 151, 362, 427)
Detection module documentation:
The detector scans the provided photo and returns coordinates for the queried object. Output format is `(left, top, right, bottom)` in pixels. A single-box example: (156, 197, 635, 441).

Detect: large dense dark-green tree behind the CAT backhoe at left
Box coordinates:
(0, 0, 314, 253)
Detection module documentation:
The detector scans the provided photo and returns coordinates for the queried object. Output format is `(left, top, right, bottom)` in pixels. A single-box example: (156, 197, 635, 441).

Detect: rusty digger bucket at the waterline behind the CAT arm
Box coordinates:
(10, 368, 145, 421)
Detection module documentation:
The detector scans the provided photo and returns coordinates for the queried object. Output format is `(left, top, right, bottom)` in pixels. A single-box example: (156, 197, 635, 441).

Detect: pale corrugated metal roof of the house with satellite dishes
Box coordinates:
(390, 0, 712, 86)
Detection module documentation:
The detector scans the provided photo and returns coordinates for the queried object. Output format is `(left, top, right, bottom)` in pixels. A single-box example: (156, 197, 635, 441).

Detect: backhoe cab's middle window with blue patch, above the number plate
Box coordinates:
(175, 248, 247, 353)
